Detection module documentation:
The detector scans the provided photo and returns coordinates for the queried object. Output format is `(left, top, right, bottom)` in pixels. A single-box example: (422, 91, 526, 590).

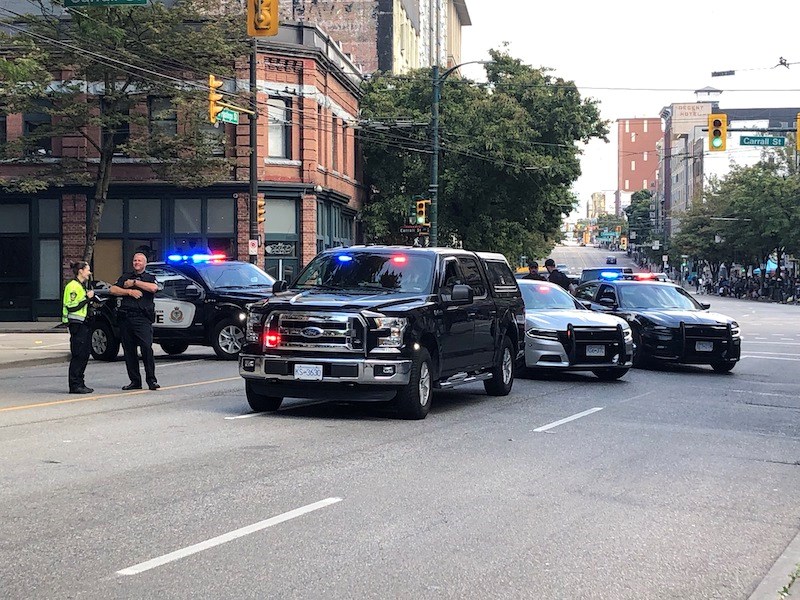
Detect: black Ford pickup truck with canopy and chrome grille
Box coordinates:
(239, 246, 525, 419)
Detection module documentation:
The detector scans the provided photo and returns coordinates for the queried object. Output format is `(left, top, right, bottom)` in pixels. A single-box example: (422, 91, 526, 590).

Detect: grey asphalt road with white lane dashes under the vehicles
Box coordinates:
(0, 249, 800, 600)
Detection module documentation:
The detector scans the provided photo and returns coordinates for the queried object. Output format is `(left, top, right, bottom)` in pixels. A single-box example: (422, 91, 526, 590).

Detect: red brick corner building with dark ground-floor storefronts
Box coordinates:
(0, 23, 365, 321)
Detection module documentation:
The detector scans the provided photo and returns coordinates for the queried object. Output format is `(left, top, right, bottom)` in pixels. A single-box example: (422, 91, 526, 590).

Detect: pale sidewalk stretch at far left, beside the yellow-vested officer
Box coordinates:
(0, 321, 70, 369)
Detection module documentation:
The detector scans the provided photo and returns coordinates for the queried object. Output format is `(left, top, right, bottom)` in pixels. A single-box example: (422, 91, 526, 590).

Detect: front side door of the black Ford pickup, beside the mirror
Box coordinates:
(439, 257, 474, 377)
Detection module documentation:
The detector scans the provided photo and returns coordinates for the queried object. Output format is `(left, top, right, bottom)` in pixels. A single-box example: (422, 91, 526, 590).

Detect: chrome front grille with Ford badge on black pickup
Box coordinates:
(268, 312, 366, 353)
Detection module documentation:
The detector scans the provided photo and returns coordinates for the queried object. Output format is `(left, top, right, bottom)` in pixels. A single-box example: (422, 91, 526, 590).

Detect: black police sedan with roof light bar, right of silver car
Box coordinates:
(575, 273, 742, 373)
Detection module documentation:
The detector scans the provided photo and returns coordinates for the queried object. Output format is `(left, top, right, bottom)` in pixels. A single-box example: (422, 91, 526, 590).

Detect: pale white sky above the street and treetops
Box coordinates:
(461, 0, 800, 219)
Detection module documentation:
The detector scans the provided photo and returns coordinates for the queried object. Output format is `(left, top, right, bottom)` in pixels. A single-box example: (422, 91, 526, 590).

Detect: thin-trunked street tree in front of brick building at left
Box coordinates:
(0, 0, 246, 261)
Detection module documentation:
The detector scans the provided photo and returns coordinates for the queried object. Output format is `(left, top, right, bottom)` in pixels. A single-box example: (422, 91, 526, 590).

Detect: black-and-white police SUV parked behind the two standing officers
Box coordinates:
(91, 254, 275, 360)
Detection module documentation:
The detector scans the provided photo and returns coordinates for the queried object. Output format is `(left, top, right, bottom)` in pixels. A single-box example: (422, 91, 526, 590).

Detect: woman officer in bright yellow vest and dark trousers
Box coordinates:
(61, 261, 94, 394)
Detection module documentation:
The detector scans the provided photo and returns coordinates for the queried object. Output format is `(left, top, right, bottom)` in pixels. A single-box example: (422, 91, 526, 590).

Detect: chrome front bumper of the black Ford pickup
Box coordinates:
(239, 354, 411, 386)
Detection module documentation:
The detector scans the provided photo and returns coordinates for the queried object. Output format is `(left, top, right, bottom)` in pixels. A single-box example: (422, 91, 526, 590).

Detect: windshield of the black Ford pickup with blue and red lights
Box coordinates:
(292, 251, 433, 294)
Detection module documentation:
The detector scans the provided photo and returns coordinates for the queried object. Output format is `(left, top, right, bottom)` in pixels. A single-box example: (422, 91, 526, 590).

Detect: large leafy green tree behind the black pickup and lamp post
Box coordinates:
(360, 51, 608, 260)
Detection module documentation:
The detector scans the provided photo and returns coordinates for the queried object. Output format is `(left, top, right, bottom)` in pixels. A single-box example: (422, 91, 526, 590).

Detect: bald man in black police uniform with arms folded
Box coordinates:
(109, 252, 161, 390)
